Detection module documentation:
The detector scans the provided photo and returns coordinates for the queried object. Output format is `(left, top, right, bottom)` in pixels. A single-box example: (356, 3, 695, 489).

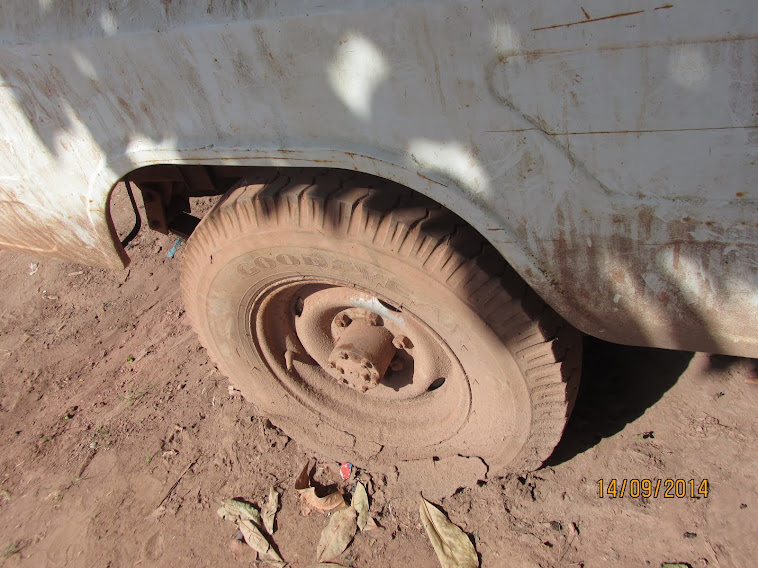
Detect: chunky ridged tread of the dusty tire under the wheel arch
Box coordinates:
(181, 168, 581, 473)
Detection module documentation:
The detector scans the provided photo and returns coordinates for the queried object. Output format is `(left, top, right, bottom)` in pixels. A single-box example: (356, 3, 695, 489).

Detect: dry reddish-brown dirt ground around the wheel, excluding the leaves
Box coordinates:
(0, 192, 758, 568)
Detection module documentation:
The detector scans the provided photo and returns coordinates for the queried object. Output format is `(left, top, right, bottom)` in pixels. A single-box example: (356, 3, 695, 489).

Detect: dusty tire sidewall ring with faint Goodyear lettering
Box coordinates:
(188, 228, 531, 466)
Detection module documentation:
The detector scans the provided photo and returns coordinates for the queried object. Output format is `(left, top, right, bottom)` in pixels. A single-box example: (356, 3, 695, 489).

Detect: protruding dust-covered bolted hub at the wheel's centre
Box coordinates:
(329, 312, 395, 392)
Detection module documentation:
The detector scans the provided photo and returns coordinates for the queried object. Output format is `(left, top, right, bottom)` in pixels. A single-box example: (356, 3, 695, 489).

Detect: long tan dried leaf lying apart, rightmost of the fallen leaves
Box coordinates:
(420, 497, 479, 568)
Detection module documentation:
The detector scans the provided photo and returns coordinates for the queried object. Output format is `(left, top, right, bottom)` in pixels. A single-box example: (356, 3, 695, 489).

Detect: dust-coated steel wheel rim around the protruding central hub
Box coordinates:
(246, 277, 471, 455)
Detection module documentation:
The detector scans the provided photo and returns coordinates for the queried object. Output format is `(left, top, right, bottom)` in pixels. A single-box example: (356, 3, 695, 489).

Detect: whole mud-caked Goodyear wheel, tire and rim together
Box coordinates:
(182, 170, 581, 481)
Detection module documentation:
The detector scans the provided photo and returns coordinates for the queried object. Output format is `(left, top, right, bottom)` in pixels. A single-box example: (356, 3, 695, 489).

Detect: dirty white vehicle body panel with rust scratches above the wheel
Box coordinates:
(0, 0, 758, 356)
